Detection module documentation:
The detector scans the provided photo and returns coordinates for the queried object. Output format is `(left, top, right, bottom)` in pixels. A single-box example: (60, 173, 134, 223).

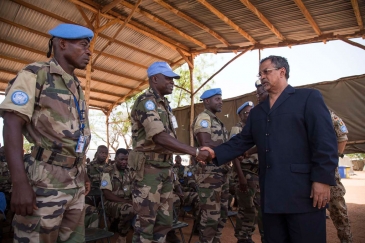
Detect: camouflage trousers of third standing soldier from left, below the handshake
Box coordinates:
(197, 173, 229, 243)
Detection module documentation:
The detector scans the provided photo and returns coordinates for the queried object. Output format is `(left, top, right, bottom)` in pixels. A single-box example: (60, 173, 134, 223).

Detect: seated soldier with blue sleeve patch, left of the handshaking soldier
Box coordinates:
(100, 148, 134, 243)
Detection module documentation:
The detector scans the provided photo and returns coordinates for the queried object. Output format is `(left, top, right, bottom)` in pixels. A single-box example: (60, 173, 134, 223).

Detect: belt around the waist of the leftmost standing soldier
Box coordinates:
(31, 146, 83, 168)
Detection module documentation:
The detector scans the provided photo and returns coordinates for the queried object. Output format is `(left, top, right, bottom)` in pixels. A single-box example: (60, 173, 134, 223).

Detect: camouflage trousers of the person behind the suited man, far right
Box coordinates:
(328, 168, 352, 243)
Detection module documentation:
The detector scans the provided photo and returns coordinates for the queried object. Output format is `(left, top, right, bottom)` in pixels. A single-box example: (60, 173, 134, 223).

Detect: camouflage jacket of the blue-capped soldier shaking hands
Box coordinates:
(131, 88, 176, 167)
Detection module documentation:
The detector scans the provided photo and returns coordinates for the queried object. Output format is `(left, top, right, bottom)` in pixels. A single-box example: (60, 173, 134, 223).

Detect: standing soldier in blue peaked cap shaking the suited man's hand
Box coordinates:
(128, 62, 209, 243)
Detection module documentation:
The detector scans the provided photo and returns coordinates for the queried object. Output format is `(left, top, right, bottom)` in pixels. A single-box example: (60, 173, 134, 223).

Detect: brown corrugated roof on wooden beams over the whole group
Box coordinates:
(0, 0, 365, 112)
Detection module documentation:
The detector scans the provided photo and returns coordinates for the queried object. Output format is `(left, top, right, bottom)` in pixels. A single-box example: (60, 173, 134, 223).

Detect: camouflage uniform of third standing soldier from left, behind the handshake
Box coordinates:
(193, 110, 229, 243)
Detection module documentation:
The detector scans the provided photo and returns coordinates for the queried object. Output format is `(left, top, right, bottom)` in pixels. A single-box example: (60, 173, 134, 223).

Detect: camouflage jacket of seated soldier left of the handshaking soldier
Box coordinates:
(100, 164, 133, 200)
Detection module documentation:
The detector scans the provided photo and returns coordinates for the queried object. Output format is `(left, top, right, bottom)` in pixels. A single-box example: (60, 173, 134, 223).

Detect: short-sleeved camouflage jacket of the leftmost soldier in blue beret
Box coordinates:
(0, 59, 90, 189)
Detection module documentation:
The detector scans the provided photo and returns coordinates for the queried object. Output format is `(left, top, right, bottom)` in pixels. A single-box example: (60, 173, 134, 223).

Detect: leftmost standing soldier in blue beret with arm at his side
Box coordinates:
(0, 24, 93, 243)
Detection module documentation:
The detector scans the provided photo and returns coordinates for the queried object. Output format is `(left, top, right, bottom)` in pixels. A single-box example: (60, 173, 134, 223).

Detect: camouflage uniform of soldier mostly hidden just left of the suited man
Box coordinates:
(230, 122, 264, 242)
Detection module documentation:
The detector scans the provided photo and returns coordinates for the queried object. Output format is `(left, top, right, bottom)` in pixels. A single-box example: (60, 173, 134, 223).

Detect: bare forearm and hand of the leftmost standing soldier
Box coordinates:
(3, 112, 38, 216)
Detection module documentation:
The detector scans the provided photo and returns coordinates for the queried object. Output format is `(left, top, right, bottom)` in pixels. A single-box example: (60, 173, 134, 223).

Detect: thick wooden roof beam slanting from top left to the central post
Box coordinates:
(67, 0, 190, 55)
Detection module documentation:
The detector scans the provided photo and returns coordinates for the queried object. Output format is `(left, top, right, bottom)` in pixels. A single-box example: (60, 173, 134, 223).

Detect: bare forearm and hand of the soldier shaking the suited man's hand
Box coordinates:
(152, 132, 211, 161)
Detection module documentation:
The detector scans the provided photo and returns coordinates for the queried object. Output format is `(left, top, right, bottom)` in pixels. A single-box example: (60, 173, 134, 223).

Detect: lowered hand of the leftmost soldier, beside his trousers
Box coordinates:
(10, 181, 38, 216)
